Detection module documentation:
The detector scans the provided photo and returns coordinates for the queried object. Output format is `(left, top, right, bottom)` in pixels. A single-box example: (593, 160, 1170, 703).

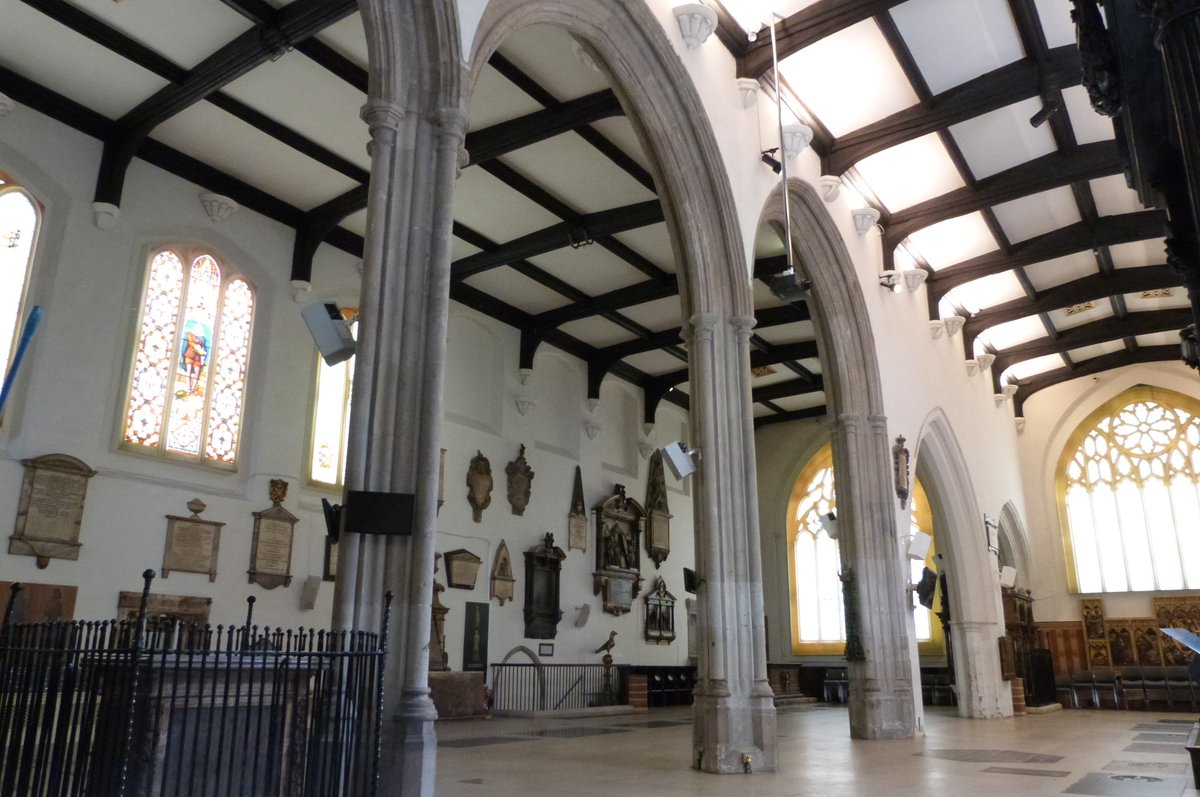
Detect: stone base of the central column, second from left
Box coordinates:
(691, 691, 776, 774)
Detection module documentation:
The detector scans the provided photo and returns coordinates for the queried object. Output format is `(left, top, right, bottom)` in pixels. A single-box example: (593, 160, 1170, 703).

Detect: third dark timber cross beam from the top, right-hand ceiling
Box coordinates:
(883, 142, 1122, 258)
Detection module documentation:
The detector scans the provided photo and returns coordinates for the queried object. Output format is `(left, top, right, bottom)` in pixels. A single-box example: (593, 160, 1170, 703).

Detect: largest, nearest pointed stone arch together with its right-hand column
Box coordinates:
(466, 0, 776, 773)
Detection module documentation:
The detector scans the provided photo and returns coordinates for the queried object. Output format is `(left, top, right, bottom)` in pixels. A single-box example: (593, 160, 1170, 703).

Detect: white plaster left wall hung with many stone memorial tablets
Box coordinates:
(0, 107, 694, 669)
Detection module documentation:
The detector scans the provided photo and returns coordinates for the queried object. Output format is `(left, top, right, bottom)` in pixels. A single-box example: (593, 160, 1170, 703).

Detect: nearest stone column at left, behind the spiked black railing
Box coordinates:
(334, 100, 464, 796)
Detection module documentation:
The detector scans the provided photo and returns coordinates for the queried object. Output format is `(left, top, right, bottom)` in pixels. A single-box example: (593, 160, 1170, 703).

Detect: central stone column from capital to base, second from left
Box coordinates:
(688, 313, 776, 773)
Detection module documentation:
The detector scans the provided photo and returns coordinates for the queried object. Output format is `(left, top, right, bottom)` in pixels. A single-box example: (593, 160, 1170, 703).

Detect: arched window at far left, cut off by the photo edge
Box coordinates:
(0, 172, 42, 417)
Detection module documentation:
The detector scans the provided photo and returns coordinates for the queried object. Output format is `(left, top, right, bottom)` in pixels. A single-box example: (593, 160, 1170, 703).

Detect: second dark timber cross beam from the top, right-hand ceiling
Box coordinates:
(822, 44, 1081, 175)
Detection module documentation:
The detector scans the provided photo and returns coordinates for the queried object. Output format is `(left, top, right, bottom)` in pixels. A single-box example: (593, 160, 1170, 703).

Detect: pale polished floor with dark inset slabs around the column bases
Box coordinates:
(437, 705, 1200, 797)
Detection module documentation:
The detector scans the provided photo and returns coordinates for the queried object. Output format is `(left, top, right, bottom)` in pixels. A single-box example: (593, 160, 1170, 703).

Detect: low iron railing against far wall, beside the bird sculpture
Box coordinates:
(492, 664, 629, 713)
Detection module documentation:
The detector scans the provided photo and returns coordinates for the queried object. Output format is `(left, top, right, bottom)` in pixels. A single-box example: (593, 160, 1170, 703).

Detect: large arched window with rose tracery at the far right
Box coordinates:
(1057, 386, 1200, 592)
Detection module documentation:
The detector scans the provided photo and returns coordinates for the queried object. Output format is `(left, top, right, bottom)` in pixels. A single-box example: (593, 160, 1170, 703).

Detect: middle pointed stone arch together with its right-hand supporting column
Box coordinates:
(760, 180, 917, 739)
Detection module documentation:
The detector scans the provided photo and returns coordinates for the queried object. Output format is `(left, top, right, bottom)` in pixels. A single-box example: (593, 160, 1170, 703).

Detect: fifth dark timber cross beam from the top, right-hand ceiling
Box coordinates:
(962, 265, 1183, 352)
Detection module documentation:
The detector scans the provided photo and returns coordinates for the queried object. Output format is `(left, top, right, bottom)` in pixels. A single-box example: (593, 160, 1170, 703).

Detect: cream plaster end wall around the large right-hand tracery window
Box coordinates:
(1019, 362, 1196, 622)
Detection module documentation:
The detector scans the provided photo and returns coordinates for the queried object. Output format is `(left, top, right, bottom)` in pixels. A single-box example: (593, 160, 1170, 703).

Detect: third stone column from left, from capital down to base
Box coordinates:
(833, 414, 917, 739)
